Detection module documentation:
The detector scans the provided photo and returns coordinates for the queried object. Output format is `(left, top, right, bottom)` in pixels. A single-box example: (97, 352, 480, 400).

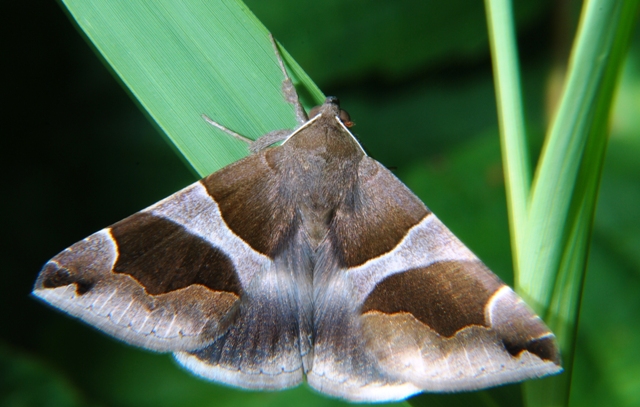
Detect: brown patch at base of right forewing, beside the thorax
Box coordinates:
(329, 157, 431, 267)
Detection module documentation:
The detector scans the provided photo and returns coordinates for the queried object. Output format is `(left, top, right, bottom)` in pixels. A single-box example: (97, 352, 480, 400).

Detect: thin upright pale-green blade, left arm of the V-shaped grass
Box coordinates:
(485, 0, 531, 266)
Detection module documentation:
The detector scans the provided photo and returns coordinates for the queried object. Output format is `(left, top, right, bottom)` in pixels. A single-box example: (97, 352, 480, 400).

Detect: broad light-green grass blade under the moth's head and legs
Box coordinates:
(63, 0, 323, 176)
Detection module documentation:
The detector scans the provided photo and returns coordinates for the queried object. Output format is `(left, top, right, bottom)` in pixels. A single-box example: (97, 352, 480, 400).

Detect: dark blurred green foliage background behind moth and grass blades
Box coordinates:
(0, 0, 640, 407)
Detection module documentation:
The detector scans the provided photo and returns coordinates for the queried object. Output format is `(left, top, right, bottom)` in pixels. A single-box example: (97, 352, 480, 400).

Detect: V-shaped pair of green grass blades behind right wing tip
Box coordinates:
(485, 0, 637, 407)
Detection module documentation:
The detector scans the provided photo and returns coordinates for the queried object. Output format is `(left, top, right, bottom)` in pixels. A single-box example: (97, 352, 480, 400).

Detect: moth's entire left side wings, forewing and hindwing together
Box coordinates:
(34, 151, 310, 388)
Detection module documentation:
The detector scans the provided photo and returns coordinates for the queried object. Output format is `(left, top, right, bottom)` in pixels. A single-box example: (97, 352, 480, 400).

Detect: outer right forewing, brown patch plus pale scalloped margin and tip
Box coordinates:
(361, 260, 562, 392)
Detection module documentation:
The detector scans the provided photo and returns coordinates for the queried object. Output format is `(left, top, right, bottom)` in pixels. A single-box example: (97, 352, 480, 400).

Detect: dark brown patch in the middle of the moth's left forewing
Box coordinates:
(111, 212, 242, 295)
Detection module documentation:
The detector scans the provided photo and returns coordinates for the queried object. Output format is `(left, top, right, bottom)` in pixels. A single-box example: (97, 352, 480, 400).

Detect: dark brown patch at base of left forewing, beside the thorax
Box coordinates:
(201, 153, 297, 258)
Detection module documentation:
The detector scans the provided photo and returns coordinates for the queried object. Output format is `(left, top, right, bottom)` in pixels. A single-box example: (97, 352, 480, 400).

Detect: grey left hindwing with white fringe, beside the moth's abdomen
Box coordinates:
(176, 236, 312, 390)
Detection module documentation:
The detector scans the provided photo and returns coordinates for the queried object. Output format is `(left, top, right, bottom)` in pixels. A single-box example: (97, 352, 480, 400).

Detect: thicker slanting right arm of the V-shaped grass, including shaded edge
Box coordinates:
(517, 0, 638, 407)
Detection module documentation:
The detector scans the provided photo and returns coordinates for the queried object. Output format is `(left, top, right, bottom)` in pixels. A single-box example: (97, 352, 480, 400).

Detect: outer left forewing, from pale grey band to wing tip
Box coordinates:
(34, 182, 250, 351)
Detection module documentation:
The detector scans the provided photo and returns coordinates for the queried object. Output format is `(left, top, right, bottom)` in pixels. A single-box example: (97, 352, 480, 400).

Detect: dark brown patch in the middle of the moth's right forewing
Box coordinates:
(362, 261, 503, 337)
